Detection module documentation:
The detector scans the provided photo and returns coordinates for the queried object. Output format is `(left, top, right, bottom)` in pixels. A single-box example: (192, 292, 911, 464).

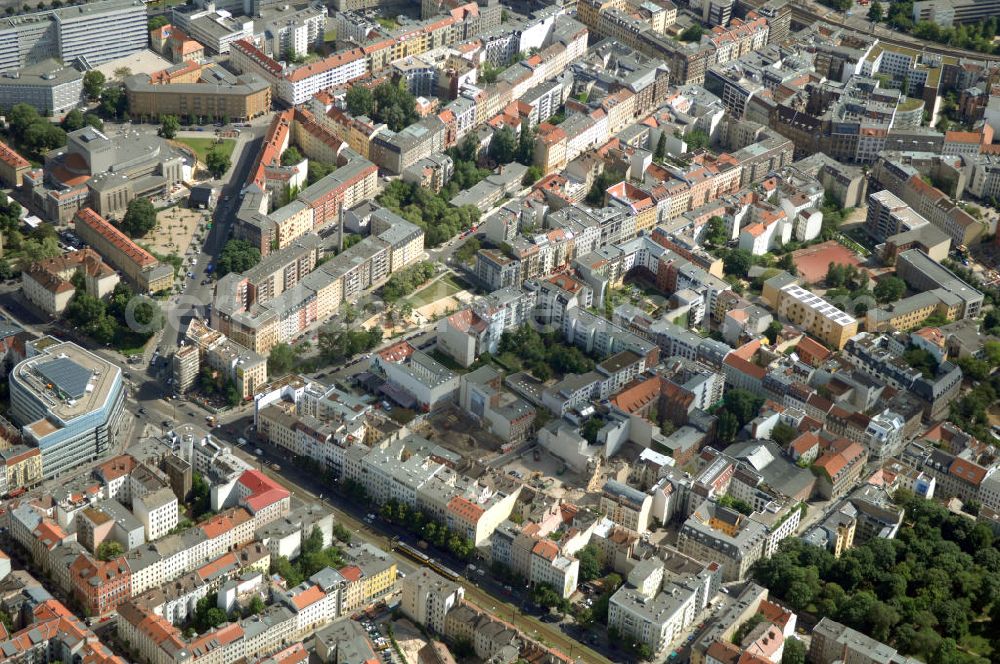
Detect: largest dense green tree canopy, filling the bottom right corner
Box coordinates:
(753, 489, 1000, 664)
